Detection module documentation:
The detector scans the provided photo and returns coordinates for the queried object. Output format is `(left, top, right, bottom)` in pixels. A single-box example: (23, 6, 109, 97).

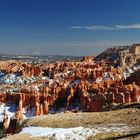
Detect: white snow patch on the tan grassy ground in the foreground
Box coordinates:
(20, 124, 129, 140)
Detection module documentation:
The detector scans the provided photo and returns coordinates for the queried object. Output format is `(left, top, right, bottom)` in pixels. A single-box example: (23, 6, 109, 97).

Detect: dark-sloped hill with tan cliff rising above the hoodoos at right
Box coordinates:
(95, 44, 140, 68)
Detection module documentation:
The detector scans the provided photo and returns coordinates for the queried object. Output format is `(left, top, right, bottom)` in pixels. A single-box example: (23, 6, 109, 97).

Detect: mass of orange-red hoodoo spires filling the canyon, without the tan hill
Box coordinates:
(0, 58, 140, 120)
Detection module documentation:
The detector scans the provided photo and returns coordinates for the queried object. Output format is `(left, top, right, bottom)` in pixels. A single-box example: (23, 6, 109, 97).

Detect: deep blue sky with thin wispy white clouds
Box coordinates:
(0, 0, 140, 56)
